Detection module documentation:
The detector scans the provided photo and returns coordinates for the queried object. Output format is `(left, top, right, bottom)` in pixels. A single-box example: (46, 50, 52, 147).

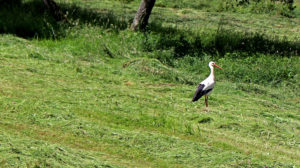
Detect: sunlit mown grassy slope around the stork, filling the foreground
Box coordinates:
(0, 0, 300, 167)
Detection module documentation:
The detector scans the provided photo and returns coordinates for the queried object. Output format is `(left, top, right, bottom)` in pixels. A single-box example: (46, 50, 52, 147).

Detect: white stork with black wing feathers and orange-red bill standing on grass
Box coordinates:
(192, 61, 223, 107)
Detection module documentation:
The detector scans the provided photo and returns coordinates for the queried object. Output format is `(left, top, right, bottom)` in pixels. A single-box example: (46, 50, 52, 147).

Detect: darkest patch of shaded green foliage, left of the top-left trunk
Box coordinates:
(0, 1, 64, 38)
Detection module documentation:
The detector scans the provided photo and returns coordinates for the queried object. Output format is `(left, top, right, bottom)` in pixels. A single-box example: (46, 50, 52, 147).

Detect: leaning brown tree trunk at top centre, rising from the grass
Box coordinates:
(131, 0, 156, 31)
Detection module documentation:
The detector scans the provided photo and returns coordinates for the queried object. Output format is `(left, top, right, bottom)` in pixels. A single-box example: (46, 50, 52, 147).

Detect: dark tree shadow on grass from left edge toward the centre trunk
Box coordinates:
(0, 0, 128, 39)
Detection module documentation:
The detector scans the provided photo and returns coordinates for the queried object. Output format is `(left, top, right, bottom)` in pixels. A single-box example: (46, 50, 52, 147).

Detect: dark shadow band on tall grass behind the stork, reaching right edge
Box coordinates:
(144, 23, 300, 58)
